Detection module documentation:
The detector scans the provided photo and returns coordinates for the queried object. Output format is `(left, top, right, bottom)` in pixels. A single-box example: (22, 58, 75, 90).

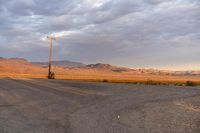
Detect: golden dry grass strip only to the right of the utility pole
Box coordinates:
(56, 75, 200, 85)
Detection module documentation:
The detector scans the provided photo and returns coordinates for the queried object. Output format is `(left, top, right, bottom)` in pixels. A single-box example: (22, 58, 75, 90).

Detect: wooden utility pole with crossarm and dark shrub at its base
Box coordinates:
(47, 35, 56, 79)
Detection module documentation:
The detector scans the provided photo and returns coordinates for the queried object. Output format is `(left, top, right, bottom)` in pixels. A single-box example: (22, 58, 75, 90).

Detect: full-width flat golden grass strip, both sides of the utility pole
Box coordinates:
(0, 73, 200, 85)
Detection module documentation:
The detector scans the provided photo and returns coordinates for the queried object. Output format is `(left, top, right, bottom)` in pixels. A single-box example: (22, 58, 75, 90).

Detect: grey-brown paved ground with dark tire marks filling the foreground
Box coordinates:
(0, 78, 200, 133)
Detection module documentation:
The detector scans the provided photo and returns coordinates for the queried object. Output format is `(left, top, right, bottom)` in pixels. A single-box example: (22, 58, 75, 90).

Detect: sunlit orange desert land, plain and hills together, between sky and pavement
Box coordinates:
(0, 58, 200, 85)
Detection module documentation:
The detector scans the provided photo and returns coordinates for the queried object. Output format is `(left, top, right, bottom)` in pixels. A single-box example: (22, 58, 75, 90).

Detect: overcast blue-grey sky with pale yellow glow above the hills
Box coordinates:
(0, 0, 200, 70)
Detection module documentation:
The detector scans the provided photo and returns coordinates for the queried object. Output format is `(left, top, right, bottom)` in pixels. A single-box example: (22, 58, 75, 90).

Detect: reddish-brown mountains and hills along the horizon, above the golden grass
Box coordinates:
(0, 57, 200, 75)
